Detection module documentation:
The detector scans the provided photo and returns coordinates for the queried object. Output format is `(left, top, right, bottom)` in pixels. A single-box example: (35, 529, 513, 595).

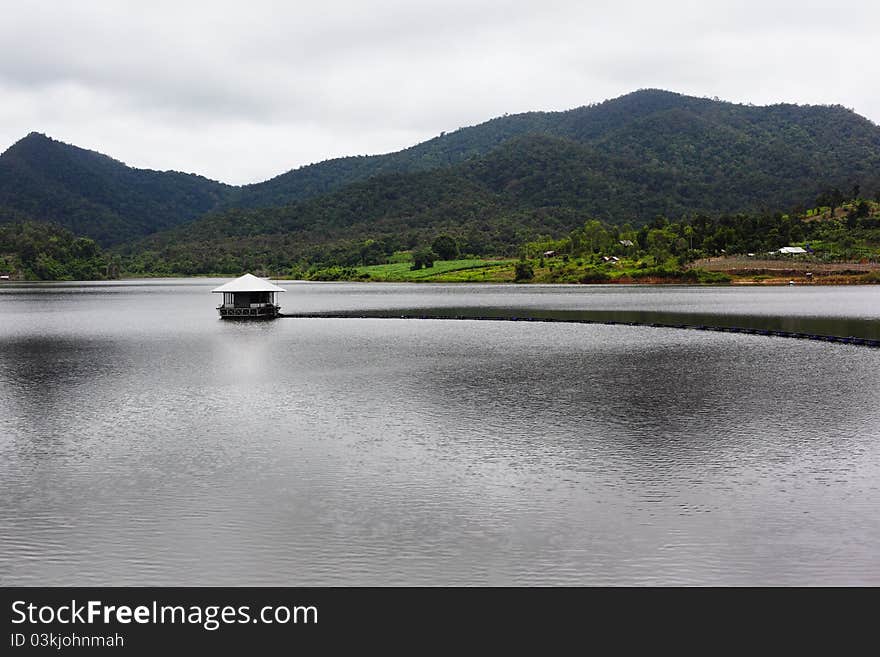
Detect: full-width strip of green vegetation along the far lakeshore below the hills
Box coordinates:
(0, 200, 880, 283)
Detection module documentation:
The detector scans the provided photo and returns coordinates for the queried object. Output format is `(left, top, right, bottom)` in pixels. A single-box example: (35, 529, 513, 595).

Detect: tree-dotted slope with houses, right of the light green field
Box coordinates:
(516, 199, 880, 283)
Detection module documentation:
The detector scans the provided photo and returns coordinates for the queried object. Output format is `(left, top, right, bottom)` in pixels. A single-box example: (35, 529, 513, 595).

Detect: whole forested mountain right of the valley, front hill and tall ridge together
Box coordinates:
(129, 90, 880, 273)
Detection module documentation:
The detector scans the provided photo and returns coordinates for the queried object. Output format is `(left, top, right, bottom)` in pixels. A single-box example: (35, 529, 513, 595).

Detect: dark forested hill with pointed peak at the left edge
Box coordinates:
(0, 132, 233, 244)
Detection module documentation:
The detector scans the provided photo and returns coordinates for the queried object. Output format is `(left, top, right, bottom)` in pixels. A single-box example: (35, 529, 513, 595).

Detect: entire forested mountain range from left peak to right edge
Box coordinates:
(0, 90, 880, 258)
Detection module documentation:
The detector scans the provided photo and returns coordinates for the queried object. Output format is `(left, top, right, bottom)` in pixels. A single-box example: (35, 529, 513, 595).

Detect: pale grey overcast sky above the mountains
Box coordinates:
(0, 0, 880, 184)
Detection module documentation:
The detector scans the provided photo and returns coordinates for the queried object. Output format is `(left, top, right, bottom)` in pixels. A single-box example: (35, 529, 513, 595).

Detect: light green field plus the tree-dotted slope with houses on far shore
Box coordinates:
(291, 200, 880, 284)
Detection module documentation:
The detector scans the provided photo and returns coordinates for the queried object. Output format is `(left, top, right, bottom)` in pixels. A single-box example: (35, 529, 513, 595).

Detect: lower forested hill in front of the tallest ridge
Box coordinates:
(125, 125, 880, 274)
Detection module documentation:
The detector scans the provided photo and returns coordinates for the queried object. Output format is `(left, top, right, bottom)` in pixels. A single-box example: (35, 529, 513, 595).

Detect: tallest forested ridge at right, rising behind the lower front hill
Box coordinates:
(229, 89, 880, 210)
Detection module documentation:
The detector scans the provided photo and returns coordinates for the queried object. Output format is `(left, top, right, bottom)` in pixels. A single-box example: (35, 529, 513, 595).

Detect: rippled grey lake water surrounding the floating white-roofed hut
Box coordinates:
(0, 279, 880, 585)
